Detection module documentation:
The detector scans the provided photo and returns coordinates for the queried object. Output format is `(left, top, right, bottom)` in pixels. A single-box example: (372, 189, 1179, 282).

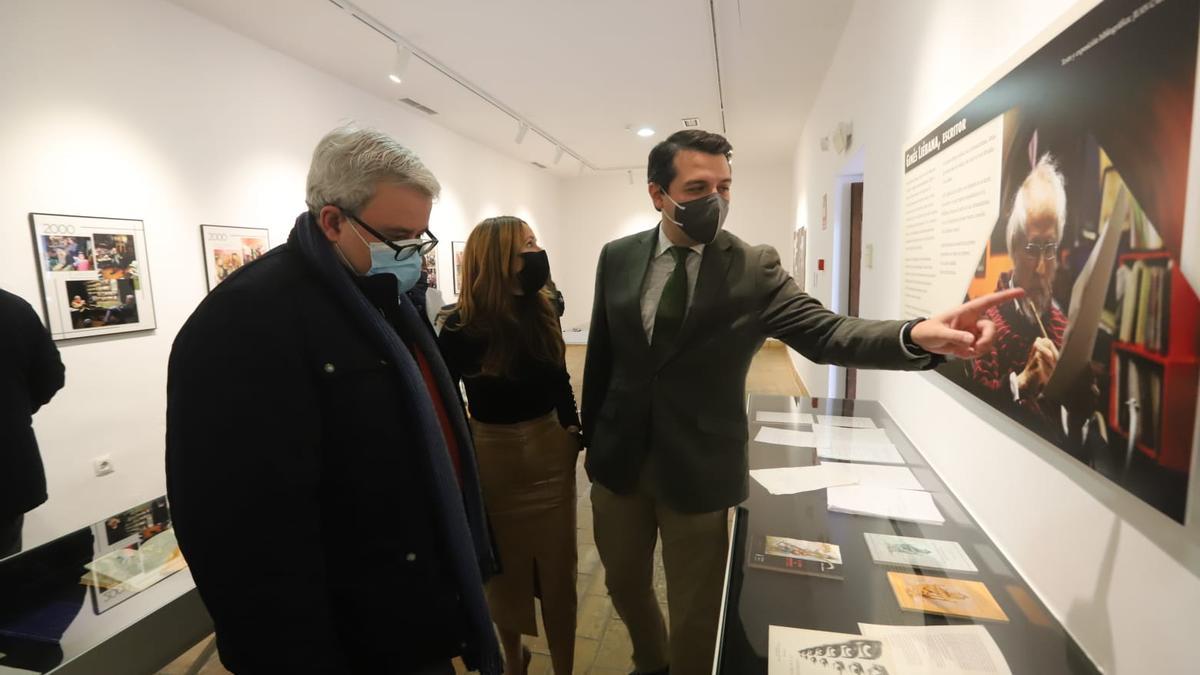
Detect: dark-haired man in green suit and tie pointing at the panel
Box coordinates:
(583, 130, 1021, 675)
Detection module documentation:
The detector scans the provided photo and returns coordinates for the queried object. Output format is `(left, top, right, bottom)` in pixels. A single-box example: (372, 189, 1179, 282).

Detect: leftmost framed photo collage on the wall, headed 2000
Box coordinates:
(29, 214, 156, 340)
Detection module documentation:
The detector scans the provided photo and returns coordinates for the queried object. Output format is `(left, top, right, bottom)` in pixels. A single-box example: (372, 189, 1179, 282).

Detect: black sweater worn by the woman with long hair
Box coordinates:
(438, 312, 580, 428)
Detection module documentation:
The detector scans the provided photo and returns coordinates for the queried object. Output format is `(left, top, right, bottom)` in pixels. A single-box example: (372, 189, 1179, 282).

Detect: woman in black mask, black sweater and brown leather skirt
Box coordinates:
(439, 216, 581, 675)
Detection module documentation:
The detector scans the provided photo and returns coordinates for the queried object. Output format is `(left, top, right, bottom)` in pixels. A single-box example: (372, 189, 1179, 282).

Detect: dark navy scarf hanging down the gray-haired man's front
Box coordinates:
(295, 213, 502, 675)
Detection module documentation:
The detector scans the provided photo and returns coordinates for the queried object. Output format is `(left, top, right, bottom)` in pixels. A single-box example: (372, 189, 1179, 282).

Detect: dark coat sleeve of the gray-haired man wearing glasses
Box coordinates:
(167, 289, 349, 674)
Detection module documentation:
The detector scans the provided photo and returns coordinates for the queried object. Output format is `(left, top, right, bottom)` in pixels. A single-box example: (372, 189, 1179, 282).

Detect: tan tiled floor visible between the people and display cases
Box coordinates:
(154, 344, 808, 675)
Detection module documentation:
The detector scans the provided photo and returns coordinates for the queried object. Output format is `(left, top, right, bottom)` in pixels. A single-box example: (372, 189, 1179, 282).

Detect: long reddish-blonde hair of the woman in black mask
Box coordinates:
(445, 216, 566, 377)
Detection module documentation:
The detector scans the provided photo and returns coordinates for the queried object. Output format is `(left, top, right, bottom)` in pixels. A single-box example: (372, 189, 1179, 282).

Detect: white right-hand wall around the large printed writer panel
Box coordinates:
(794, 0, 1200, 673)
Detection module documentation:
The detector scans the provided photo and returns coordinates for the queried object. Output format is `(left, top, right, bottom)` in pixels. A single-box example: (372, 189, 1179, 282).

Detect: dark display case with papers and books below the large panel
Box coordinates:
(716, 395, 1098, 675)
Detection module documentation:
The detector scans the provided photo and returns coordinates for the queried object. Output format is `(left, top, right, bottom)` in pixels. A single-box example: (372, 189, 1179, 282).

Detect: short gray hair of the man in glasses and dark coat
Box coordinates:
(305, 126, 442, 215)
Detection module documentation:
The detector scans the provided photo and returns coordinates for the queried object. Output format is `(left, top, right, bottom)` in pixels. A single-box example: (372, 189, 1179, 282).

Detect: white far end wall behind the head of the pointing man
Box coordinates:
(546, 159, 793, 329)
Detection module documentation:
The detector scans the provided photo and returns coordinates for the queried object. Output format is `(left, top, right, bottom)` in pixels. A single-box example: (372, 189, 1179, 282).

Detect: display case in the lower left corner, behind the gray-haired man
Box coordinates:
(0, 497, 212, 675)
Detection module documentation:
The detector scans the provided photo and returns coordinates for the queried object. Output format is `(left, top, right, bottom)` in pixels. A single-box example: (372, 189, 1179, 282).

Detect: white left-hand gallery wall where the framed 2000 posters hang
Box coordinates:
(0, 0, 562, 546)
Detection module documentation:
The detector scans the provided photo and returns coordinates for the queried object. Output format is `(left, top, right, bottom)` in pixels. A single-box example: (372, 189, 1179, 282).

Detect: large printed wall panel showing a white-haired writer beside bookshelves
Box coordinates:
(901, 0, 1200, 521)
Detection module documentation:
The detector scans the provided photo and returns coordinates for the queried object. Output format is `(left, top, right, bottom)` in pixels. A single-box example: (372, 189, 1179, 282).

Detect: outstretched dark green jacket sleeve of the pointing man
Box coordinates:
(758, 246, 931, 370)
